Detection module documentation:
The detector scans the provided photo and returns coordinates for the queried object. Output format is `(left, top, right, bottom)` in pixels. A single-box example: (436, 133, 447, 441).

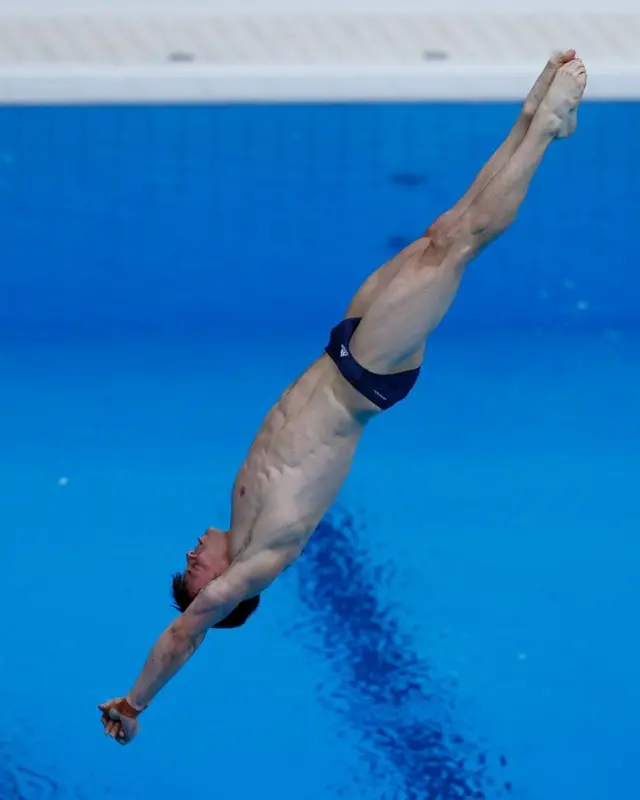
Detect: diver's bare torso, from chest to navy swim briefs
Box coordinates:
(230, 356, 374, 559)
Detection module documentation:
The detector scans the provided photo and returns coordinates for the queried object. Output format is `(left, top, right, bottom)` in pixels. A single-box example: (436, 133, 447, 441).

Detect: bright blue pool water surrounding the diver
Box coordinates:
(0, 104, 640, 800)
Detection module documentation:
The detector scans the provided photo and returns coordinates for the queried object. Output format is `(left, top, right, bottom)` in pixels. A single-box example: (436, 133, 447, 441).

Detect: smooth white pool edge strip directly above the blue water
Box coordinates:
(0, 63, 640, 105)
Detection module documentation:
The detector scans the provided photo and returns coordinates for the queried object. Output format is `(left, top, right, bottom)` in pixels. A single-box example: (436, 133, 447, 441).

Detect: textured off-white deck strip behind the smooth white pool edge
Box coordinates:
(0, 10, 640, 66)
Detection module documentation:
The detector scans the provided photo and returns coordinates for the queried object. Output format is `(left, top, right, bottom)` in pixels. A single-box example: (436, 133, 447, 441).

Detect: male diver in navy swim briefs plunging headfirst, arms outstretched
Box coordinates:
(99, 50, 587, 744)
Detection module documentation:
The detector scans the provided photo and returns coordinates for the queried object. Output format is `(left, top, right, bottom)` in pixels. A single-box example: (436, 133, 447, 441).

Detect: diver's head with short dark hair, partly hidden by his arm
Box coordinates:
(171, 528, 260, 628)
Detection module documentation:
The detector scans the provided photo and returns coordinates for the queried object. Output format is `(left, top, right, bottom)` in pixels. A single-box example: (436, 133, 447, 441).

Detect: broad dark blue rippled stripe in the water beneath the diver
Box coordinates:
(292, 510, 512, 800)
